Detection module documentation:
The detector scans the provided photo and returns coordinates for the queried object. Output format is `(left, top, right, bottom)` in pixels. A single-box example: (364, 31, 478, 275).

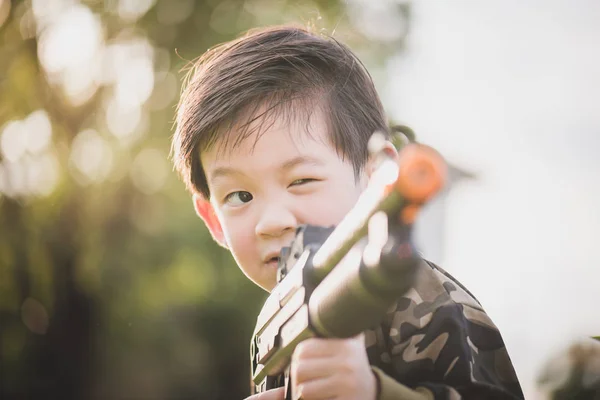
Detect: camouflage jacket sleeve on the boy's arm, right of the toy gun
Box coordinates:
(366, 263, 524, 400)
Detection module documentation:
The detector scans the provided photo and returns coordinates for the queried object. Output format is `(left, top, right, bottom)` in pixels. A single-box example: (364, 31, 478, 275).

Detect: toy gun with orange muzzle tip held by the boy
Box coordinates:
(251, 132, 446, 400)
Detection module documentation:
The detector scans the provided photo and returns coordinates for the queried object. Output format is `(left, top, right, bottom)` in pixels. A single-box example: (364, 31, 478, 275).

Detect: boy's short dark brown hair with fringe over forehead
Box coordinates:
(172, 26, 388, 199)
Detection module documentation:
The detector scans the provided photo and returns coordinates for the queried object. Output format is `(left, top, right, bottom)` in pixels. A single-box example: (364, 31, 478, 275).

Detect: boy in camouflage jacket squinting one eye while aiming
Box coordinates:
(173, 26, 523, 400)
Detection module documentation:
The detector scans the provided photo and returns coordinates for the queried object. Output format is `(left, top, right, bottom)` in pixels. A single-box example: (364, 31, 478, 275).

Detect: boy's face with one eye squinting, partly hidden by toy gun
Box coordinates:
(202, 109, 367, 291)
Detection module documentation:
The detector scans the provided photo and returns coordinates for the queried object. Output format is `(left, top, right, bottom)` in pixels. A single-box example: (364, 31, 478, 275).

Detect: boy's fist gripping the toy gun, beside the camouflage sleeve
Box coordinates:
(291, 334, 377, 400)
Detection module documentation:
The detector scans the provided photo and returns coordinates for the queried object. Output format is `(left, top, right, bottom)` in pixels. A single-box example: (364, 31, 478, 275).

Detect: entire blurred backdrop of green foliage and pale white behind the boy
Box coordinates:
(0, 0, 600, 399)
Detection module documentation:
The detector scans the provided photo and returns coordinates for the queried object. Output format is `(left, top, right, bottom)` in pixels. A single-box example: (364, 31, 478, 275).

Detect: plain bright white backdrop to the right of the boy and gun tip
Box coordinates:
(382, 0, 600, 399)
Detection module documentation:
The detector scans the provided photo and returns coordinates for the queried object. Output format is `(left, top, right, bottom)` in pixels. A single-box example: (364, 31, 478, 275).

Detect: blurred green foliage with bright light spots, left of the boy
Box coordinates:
(0, 0, 408, 399)
